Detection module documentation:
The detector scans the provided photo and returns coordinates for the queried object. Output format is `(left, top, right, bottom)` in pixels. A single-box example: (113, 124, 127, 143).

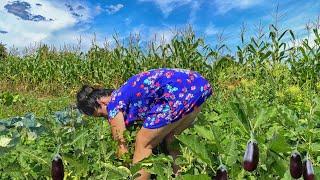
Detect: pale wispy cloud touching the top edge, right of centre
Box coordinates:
(214, 0, 263, 14)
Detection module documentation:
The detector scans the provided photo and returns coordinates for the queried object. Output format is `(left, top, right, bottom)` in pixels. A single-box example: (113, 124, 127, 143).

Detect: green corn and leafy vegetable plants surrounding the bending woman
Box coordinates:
(0, 26, 320, 179)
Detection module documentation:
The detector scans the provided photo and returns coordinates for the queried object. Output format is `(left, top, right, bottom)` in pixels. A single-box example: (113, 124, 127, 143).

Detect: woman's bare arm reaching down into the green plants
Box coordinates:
(110, 112, 128, 157)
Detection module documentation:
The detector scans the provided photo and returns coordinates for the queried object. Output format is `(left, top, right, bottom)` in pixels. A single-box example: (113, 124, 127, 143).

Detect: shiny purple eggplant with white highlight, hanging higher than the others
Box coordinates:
(243, 140, 259, 172)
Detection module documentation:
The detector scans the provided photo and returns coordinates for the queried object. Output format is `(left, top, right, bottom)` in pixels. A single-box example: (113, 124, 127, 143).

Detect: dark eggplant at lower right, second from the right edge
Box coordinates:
(290, 151, 303, 179)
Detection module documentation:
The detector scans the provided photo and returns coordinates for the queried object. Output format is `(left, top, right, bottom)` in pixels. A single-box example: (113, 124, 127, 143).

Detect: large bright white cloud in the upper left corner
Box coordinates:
(0, 0, 91, 48)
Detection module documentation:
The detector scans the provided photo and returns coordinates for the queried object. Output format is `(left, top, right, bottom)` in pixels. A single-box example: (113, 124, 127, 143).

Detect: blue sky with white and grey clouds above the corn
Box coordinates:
(0, 0, 320, 49)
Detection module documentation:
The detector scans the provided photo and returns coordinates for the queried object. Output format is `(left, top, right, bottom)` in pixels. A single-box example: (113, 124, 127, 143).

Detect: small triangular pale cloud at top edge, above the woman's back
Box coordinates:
(139, 0, 192, 17)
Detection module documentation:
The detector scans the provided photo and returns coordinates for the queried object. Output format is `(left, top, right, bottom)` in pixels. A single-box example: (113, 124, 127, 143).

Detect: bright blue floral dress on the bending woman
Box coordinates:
(107, 68, 212, 129)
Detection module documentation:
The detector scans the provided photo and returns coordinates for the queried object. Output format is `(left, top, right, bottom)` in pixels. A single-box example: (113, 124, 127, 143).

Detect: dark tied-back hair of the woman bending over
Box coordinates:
(77, 85, 114, 116)
